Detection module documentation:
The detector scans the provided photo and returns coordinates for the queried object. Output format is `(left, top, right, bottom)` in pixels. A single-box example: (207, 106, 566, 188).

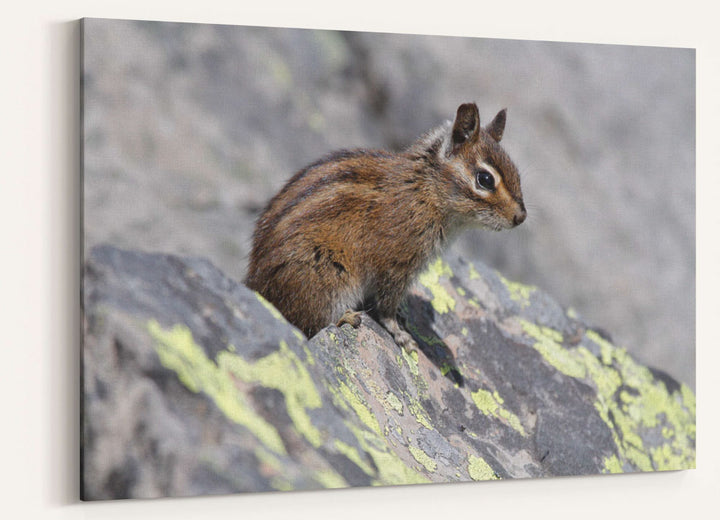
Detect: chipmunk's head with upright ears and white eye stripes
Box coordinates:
(446, 103, 527, 230)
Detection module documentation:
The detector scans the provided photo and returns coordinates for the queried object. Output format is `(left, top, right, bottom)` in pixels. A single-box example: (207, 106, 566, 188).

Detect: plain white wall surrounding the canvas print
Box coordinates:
(0, 0, 720, 520)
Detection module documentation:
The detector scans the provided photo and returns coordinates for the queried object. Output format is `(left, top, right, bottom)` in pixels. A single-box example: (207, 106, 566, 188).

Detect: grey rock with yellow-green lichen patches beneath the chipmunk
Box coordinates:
(82, 246, 695, 499)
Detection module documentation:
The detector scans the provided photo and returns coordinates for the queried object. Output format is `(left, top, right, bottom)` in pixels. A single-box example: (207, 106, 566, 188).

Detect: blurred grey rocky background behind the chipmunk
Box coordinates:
(83, 19, 695, 388)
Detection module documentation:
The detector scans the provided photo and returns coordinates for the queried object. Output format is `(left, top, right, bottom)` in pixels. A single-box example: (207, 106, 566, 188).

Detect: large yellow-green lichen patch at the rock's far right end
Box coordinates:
(521, 320, 695, 472)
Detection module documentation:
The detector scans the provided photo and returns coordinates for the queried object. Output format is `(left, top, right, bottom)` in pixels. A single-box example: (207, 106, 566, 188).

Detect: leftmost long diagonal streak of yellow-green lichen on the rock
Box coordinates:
(147, 320, 286, 454)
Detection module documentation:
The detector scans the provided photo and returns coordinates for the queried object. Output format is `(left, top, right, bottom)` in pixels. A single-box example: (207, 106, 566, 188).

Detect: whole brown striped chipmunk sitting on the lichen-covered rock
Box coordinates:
(245, 103, 527, 350)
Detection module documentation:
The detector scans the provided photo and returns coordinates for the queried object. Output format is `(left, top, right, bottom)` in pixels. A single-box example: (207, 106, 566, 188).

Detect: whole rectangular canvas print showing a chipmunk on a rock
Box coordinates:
(80, 19, 695, 500)
